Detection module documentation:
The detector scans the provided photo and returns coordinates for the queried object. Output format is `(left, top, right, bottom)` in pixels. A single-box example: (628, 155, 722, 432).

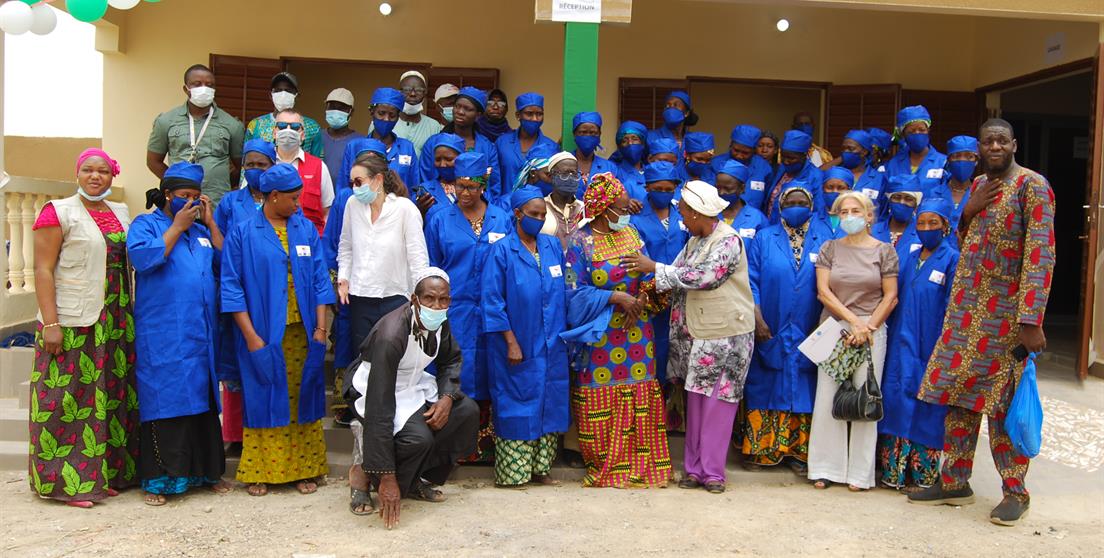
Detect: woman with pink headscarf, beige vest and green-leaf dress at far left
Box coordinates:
(29, 149, 142, 507)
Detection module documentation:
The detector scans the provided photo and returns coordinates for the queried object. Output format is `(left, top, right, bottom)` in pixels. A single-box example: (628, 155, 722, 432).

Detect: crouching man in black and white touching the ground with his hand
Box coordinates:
(344, 267, 479, 529)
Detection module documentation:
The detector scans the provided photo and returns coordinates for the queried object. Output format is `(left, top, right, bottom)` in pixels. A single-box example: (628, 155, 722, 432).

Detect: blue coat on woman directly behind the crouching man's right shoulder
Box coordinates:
(425, 201, 513, 401)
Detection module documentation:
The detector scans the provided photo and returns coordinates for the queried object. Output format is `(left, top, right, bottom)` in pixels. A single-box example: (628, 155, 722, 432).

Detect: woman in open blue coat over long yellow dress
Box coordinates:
(221, 164, 336, 496)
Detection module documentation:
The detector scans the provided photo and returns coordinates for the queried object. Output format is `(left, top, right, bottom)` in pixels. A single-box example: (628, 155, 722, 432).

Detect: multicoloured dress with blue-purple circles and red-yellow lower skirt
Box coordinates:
(566, 227, 671, 488)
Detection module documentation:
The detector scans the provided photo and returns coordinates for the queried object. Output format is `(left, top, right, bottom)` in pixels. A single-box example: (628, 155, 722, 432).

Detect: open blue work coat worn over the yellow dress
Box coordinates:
(221, 211, 336, 429)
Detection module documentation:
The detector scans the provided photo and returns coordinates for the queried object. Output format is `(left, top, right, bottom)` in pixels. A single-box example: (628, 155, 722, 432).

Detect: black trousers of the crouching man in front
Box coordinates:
(384, 398, 479, 497)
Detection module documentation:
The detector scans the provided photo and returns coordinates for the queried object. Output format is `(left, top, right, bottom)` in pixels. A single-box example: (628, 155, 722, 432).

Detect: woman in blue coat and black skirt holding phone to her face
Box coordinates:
(127, 162, 230, 506)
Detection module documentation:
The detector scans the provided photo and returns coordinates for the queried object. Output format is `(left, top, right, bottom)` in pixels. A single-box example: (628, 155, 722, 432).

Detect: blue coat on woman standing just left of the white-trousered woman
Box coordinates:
(744, 219, 832, 413)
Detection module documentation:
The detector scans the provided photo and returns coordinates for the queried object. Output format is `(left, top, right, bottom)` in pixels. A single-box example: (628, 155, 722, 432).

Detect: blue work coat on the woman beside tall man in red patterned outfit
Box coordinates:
(878, 239, 958, 449)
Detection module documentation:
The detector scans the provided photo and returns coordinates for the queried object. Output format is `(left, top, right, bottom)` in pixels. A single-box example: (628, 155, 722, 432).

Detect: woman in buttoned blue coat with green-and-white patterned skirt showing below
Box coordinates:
(481, 186, 570, 487)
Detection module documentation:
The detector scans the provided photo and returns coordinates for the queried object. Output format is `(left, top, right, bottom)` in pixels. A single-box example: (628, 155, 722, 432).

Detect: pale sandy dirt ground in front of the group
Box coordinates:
(0, 464, 1104, 557)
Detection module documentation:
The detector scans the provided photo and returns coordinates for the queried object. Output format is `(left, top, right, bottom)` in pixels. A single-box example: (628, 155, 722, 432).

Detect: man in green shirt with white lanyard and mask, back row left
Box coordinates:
(146, 64, 245, 203)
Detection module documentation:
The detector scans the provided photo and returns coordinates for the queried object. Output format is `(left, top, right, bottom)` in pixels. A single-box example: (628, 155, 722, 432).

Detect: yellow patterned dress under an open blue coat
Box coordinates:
(237, 228, 329, 484)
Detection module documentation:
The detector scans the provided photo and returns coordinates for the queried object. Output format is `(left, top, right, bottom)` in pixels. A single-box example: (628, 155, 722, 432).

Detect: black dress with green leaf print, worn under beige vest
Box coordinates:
(29, 204, 139, 502)
